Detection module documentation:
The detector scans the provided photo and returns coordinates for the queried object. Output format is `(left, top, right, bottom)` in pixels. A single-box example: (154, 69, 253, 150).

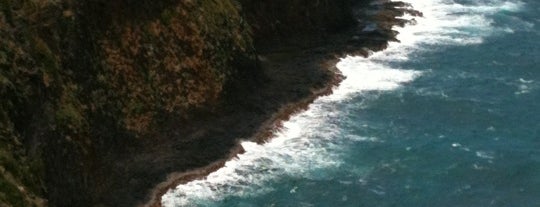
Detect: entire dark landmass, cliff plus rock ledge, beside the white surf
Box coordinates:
(0, 0, 420, 206)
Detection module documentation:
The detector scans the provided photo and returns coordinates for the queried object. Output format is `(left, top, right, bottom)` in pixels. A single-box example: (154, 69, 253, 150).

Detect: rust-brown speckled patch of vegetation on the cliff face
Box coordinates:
(97, 0, 255, 134)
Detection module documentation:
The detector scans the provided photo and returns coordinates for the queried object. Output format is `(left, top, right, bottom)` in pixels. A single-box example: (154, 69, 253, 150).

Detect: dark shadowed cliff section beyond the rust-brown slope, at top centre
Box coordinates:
(240, 0, 361, 47)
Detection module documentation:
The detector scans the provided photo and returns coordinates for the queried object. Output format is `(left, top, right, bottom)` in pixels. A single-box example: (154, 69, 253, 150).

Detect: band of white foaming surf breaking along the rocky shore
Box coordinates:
(162, 0, 522, 206)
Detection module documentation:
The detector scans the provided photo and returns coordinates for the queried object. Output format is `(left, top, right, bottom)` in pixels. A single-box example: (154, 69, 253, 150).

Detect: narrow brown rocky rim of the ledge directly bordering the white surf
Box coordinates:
(141, 0, 422, 207)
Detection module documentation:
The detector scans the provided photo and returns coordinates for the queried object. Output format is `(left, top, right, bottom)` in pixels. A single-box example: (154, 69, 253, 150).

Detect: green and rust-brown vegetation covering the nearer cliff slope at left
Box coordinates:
(0, 0, 251, 206)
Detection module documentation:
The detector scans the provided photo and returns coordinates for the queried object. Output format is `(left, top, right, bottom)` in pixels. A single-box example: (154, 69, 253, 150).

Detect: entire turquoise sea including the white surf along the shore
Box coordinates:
(163, 0, 540, 207)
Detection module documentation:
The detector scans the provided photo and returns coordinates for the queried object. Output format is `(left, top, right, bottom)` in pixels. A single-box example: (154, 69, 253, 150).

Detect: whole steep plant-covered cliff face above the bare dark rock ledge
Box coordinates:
(0, 0, 358, 206)
